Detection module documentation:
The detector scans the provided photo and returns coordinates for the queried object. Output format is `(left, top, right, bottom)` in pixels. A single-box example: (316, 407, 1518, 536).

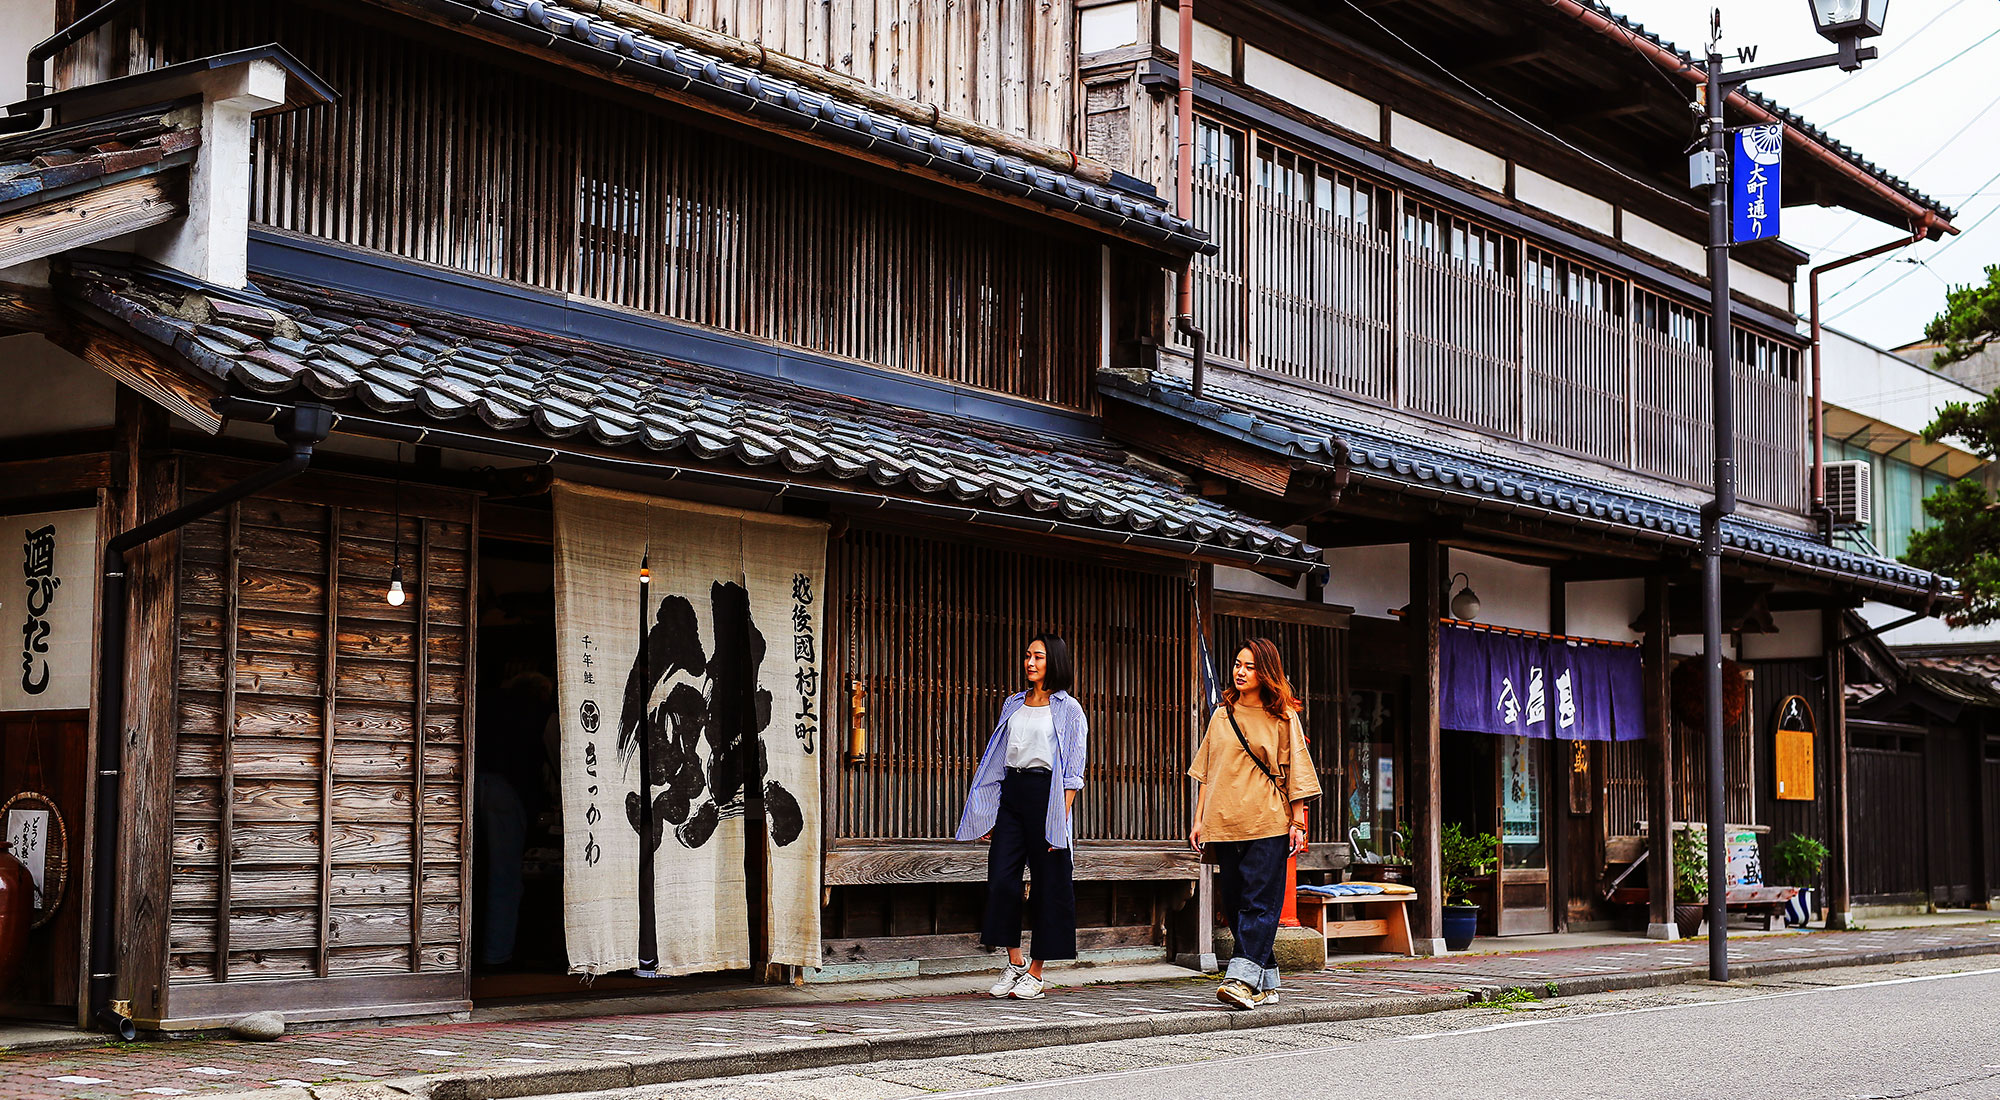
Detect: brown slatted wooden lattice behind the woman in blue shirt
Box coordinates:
(832, 530, 1194, 842)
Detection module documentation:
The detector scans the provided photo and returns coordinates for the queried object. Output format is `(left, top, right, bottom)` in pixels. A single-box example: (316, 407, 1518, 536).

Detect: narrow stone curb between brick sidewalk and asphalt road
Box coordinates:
(191, 944, 2000, 1100)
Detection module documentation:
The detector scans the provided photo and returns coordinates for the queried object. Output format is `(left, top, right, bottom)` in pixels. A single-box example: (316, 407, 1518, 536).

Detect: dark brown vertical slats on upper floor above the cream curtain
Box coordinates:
(136, 0, 1100, 408)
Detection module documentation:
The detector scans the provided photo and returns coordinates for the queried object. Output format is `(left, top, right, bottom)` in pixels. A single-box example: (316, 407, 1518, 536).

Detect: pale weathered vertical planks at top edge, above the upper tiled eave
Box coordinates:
(638, 0, 1076, 148)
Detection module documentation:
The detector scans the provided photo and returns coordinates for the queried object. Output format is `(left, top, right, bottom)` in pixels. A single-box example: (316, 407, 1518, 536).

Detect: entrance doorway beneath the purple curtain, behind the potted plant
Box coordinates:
(1440, 730, 1556, 936)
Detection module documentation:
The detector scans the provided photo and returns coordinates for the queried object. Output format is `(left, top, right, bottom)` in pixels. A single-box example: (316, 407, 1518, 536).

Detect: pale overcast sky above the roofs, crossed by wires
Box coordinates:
(1608, 0, 2000, 348)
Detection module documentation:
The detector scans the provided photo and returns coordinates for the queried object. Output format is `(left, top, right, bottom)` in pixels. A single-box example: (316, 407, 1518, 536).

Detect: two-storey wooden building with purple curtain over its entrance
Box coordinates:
(1080, 0, 1952, 948)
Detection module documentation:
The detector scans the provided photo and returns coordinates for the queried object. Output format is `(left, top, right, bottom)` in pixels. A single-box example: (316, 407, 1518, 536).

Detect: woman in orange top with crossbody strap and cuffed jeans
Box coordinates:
(1188, 638, 1320, 1008)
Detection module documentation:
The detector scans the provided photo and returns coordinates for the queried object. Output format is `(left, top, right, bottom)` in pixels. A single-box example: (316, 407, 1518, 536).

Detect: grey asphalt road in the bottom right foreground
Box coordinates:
(560, 960, 2000, 1100)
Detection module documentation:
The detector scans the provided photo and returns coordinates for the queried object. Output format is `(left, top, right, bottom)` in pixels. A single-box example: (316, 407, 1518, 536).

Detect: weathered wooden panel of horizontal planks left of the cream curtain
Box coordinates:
(168, 470, 472, 984)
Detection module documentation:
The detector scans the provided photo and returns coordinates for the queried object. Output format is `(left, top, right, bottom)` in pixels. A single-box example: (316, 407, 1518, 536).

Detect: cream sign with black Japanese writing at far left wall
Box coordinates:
(0, 508, 98, 710)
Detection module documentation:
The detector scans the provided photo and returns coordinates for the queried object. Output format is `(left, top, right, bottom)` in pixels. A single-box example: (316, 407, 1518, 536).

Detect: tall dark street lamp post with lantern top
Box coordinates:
(1696, 0, 1888, 982)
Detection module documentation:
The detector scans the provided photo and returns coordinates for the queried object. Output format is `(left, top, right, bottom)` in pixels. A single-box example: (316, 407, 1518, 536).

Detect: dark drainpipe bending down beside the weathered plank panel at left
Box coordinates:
(90, 404, 334, 1040)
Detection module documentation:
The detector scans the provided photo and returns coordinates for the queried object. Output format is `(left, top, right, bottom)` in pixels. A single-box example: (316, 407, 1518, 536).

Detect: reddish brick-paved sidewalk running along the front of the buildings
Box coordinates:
(0, 922, 2000, 1100)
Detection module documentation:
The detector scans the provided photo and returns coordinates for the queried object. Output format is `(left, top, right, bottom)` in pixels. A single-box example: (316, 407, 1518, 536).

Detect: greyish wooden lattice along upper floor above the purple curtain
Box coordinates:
(1196, 120, 1810, 510)
